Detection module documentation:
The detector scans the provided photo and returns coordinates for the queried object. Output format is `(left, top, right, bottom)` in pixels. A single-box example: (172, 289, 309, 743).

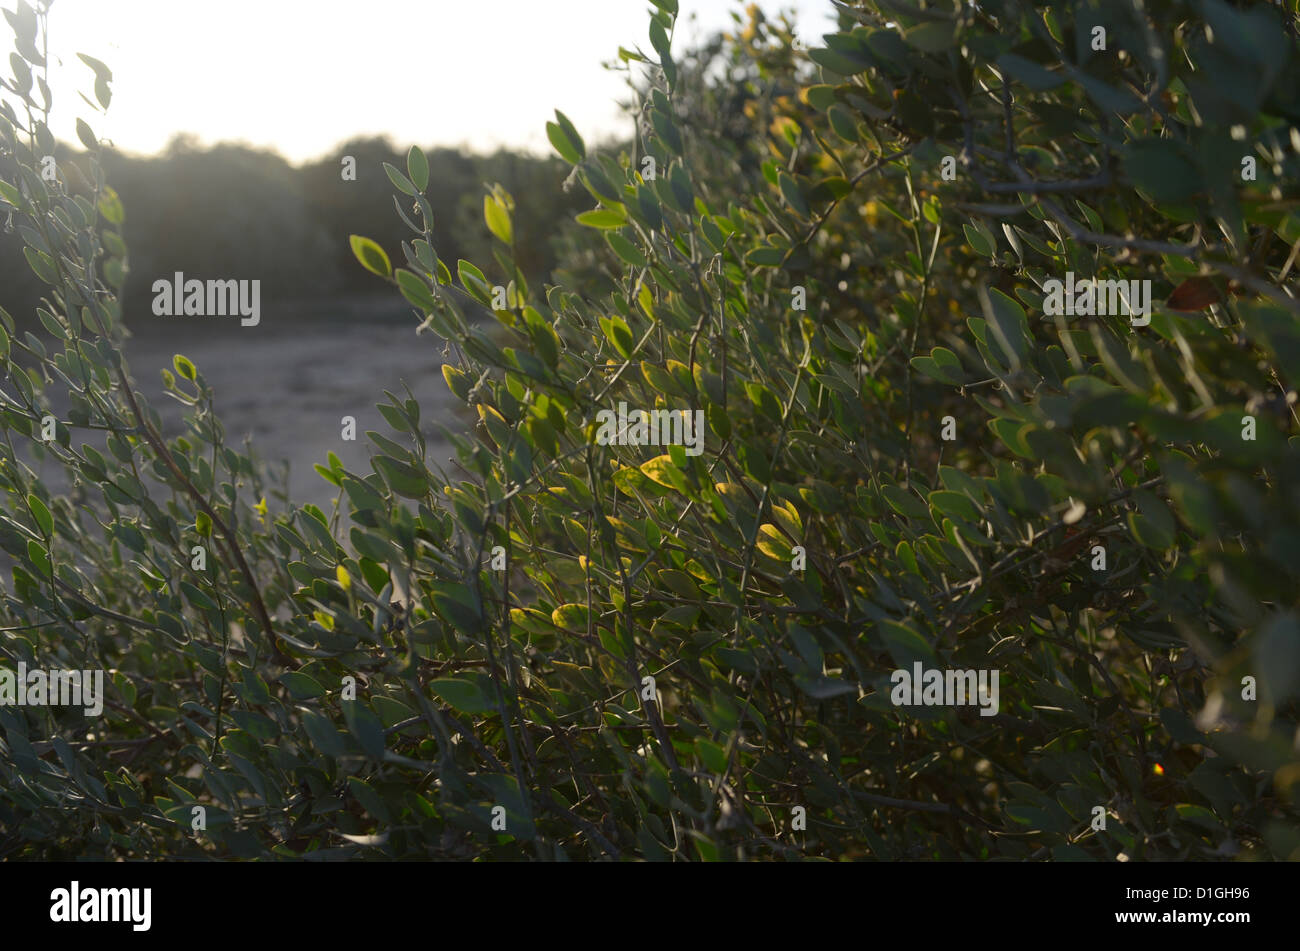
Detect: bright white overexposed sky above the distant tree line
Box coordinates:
(0, 0, 833, 161)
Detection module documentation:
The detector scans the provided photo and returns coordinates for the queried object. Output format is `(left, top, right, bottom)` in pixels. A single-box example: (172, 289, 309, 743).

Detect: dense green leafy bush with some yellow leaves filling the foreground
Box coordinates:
(0, 0, 1300, 860)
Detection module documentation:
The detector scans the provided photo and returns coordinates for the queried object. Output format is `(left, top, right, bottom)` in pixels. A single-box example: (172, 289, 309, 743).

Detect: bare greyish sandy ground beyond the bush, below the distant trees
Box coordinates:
(25, 299, 465, 517)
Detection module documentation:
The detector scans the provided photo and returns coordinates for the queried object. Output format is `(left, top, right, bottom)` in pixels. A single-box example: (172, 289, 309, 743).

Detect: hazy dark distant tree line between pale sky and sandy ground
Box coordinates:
(0, 135, 590, 327)
